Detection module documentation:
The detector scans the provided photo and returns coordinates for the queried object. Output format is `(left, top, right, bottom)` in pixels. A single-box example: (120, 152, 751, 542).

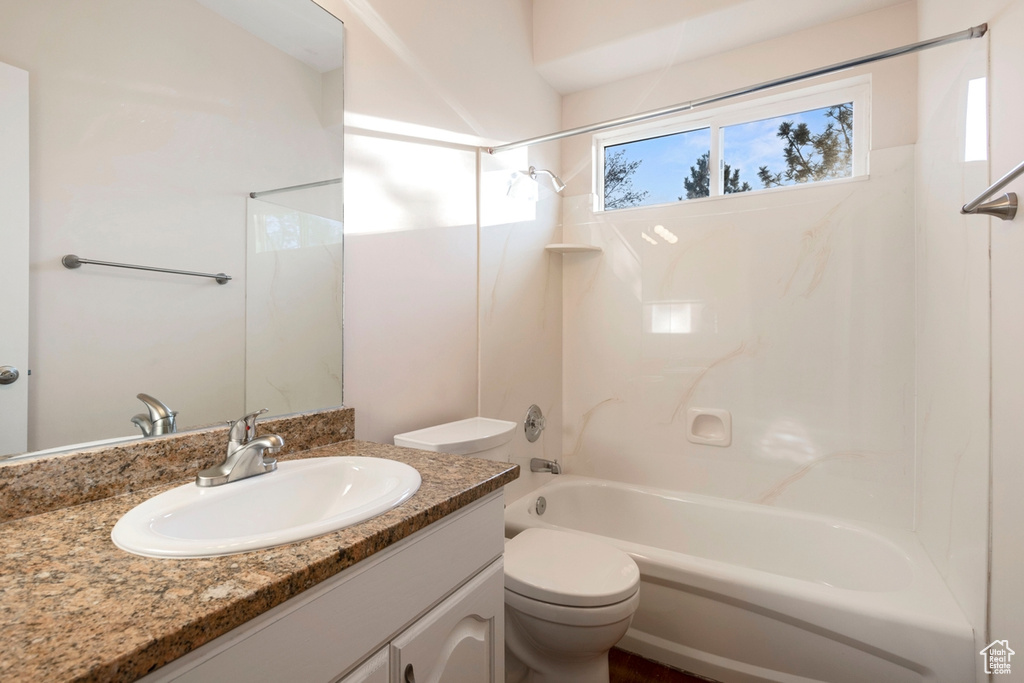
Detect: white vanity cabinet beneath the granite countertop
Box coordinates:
(142, 490, 505, 683)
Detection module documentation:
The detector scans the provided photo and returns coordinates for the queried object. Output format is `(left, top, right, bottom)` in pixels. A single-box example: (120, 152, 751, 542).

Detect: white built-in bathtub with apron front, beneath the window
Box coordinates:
(505, 474, 980, 683)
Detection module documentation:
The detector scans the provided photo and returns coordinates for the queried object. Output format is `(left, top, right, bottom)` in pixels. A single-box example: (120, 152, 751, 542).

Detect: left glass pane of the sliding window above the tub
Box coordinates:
(604, 128, 711, 209)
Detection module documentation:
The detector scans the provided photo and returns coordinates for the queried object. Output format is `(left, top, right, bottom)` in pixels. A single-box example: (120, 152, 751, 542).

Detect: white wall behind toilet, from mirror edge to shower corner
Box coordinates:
(322, 0, 561, 475)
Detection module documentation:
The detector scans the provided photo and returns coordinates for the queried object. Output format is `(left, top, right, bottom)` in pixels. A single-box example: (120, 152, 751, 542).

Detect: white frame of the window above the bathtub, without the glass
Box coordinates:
(592, 74, 871, 212)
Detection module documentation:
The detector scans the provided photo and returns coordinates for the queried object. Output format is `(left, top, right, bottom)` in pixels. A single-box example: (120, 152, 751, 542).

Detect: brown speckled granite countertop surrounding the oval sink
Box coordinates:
(0, 440, 518, 681)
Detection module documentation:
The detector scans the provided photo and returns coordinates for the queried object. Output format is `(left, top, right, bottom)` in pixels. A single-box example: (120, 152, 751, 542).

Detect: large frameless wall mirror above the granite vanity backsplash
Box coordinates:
(0, 0, 344, 457)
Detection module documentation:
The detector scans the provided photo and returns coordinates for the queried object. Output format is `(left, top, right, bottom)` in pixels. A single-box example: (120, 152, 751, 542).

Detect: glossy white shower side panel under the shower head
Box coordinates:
(480, 145, 564, 500)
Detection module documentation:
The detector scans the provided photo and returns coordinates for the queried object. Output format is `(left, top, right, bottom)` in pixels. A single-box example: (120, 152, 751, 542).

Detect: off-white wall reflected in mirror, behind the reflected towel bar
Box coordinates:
(0, 0, 342, 450)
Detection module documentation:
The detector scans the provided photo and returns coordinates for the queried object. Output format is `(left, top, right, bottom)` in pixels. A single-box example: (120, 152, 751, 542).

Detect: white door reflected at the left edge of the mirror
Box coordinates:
(0, 62, 29, 456)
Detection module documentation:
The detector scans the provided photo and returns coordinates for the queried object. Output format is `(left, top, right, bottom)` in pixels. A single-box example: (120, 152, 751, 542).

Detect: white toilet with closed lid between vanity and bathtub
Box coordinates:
(394, 418, 640, 683)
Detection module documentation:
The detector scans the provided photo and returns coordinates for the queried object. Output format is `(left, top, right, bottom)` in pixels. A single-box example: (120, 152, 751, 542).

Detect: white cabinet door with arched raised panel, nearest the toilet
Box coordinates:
(391, 558, 505, 683)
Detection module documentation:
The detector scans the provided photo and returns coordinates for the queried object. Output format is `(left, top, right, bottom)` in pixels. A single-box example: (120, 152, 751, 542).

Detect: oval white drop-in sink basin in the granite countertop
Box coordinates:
(111, 456, 420, 557)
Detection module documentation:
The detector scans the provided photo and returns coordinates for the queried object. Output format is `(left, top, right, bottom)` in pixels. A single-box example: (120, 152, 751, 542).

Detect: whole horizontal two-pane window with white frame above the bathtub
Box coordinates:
(595, 79, 868, 211)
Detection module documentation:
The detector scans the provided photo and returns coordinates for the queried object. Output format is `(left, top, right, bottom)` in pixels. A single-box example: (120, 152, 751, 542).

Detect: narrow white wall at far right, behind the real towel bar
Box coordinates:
(921, 0, 1024, 681)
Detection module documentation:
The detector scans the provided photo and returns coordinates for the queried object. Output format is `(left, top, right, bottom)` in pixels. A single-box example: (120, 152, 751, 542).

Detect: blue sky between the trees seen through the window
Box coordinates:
(605, 102, 847, 205)
